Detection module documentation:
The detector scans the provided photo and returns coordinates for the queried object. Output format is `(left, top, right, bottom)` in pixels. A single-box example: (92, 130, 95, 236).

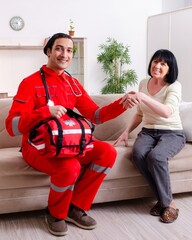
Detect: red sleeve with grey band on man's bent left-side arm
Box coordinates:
(5, 81, 51, 136)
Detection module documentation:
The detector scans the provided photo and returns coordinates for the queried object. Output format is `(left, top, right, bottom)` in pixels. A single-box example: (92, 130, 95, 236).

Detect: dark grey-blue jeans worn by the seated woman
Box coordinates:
(133, 128, 186, 207)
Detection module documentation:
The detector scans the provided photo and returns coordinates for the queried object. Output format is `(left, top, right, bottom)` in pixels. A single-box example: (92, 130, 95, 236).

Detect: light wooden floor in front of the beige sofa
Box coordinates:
(0, 193, 192, 240)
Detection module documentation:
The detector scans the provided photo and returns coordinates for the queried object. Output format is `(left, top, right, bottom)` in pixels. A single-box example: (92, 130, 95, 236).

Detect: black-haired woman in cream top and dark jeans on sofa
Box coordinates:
(114, 49, 186, 223)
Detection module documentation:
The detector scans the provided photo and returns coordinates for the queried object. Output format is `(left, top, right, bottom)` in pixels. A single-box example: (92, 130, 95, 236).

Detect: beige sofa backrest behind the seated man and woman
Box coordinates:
(0, 94, 140, 148)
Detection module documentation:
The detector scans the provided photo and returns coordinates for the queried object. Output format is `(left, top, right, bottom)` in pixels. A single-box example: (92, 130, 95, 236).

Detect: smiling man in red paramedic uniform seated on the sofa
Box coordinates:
(6, 33, 137, 236)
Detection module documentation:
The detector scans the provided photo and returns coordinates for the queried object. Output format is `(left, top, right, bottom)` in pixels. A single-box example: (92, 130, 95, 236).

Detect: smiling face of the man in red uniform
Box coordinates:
(47, 38, 73, 74)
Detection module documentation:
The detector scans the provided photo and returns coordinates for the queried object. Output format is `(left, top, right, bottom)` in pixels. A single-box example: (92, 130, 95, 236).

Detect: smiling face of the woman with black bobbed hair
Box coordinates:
(150, 59, 169, 79)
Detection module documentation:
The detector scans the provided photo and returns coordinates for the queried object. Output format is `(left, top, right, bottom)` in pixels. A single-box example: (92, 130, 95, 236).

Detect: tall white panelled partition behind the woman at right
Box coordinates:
(148, 7, 192, 101)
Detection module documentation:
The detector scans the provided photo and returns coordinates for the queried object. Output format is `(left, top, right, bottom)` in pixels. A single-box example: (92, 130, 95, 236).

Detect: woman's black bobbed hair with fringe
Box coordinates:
(148, 49, 179, 83)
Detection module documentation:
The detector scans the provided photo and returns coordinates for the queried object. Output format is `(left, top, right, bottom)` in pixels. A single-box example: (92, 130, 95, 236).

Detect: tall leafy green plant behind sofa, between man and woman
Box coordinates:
(97, 38, 137, 94)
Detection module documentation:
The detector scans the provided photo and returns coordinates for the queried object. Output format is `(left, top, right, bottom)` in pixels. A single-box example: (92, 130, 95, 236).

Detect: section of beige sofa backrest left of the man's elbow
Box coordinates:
(0, 98, 21, 148)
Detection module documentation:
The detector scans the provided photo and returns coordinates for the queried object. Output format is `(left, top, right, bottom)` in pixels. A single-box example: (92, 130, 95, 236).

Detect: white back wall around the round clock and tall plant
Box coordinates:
(0, 0, 162, 94)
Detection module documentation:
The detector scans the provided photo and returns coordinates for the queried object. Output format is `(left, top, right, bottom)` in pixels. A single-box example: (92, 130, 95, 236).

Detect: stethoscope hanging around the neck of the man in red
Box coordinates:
(40, 68, 82, 106)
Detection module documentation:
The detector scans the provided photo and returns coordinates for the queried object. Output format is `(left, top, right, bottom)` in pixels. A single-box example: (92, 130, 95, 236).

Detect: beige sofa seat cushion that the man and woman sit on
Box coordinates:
(0, 139, 192, 189)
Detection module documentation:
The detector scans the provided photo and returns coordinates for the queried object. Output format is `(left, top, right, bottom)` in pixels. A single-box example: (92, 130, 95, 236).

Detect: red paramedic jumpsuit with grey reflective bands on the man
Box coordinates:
(6, 65, 125, 219)
